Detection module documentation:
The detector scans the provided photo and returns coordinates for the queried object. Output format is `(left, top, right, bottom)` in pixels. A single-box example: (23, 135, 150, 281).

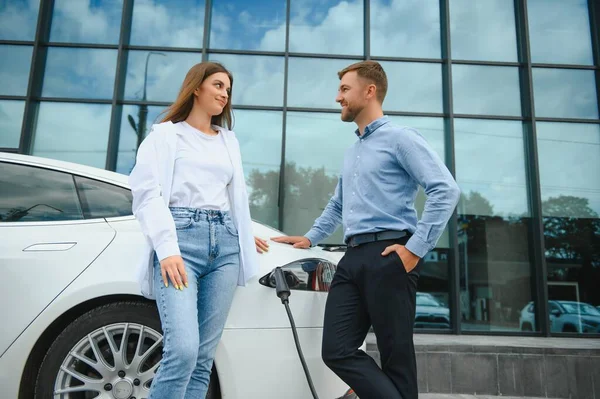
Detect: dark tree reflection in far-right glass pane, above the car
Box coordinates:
(542, 195, 600, 305)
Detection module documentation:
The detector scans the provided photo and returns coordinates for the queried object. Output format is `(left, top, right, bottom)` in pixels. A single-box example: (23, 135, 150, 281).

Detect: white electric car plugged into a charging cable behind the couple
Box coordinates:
(0, 153, 347, 399)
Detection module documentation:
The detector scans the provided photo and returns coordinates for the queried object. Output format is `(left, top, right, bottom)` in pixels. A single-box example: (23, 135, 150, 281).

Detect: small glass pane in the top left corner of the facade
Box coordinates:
(0, 0, 40, 41)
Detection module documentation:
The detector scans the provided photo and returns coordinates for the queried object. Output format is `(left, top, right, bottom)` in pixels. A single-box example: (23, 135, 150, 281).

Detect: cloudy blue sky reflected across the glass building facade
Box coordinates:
(0, 0, 600, 216)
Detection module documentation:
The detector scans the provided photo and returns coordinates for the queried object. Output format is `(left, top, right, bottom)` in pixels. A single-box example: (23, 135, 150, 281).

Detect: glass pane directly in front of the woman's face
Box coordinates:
(209, 54, 284, 107)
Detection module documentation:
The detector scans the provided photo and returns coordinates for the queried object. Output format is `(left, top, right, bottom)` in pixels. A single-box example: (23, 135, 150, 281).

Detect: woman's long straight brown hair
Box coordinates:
(161, 62, 233, 129)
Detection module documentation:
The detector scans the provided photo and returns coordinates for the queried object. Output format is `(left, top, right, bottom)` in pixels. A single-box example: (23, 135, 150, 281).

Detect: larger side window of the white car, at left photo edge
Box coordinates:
(0, 162, 83, 222)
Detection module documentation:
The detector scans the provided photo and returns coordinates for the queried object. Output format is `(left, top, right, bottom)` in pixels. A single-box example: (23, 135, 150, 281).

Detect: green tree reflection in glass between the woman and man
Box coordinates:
(248, 162, 338, 231)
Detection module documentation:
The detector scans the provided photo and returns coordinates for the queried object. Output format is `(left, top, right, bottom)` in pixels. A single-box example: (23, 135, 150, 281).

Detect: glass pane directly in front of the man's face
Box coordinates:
(287, 57, 357, 109)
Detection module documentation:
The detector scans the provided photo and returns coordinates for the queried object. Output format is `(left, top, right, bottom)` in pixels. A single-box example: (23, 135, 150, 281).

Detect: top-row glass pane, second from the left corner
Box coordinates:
(50, 0, 123, 44)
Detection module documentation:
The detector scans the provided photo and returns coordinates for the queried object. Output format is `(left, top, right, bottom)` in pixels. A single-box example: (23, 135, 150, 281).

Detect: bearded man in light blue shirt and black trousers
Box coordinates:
(273, 61, 459, 399)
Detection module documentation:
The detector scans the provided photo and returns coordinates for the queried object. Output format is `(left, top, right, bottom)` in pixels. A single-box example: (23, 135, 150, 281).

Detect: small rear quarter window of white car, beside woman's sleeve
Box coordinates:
(75, 176, 133, 219)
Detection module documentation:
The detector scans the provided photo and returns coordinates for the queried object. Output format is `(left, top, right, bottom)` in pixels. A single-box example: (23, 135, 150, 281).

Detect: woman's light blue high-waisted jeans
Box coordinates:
(149, 208, 240, 399)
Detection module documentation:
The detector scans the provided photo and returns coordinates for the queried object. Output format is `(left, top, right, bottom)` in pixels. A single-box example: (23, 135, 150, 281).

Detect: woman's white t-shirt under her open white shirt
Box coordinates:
(169, 122, 233, 211)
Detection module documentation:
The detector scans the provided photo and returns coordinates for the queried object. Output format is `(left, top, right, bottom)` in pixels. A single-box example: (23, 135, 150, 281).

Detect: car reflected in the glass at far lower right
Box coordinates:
(519, 300, 600, 333)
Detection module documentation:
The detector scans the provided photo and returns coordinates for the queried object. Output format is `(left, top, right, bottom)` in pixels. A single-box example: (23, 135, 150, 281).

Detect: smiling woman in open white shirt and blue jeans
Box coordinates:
(129, 62, 268, 399)
